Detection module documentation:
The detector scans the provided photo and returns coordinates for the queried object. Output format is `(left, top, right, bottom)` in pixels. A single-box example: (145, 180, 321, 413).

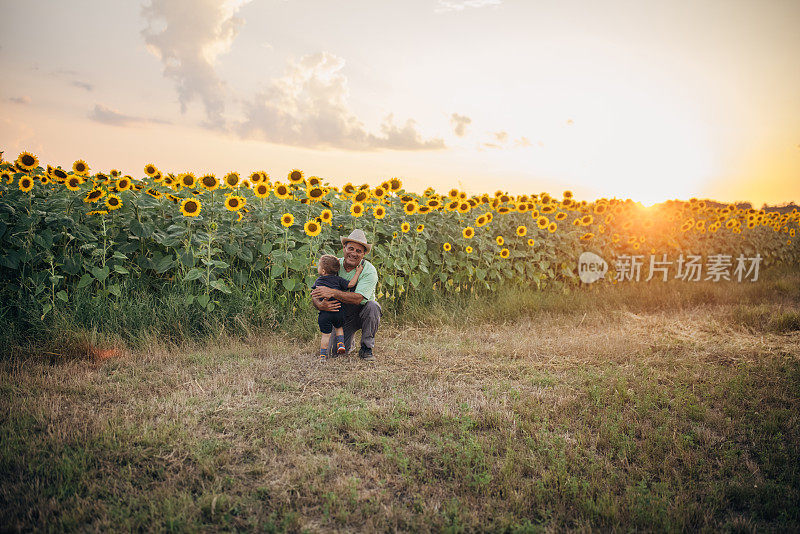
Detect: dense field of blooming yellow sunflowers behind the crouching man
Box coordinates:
(0, 152, 800, 338)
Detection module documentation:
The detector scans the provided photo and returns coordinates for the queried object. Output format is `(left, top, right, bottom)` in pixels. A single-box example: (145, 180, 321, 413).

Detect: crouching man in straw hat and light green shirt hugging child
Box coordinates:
(311, 228, 381, 361)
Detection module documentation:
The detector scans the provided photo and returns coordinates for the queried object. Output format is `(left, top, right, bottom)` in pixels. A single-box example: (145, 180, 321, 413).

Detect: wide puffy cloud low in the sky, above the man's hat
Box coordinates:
(236, 52, 445, 150)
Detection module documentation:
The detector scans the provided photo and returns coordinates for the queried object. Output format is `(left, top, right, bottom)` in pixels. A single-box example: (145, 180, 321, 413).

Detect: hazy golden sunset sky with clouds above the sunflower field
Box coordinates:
(0, 0, 800, 206)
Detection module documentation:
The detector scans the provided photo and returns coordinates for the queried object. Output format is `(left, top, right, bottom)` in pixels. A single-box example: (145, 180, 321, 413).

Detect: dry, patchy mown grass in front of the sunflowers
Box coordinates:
(0, 271, 800, 532)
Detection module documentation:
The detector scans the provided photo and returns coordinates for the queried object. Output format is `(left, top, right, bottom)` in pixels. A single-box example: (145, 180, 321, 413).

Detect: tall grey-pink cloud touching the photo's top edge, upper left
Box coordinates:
(142, 0, 250, 128)
